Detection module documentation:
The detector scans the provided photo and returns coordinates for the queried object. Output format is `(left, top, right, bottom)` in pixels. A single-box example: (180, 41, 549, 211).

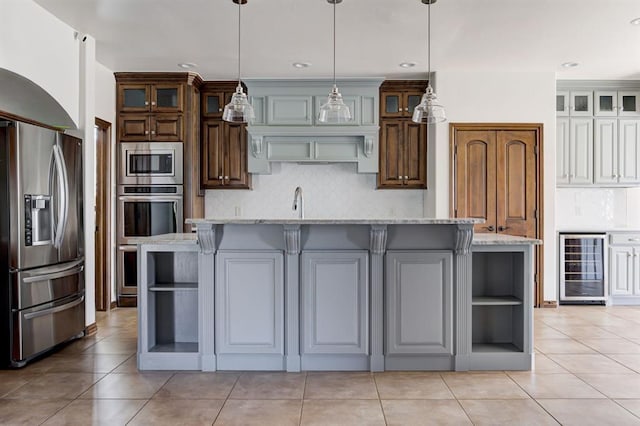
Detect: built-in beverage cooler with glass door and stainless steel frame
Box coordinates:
(559, 233, 609, 304)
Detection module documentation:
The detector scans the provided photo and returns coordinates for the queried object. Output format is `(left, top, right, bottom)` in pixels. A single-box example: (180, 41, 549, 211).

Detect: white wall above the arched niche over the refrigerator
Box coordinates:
(0, 0, 80, 124)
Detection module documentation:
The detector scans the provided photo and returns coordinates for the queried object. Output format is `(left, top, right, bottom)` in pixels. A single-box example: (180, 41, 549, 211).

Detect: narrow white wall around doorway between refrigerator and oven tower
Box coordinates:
(95, 62, 117, 302)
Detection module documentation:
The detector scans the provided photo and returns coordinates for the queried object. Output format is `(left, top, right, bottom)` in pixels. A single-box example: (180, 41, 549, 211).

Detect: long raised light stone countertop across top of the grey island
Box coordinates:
(186, 217, 484, 225)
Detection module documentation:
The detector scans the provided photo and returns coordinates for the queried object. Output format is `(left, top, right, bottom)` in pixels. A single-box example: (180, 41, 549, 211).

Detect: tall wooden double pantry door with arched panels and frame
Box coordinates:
(450, 123, 543, 306)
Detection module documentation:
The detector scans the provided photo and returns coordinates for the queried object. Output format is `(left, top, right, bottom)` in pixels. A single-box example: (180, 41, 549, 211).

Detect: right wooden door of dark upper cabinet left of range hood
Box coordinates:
(222, 123, 251, 189)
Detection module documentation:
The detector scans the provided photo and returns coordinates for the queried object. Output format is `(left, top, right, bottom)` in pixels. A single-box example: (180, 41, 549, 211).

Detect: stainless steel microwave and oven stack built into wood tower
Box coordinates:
(116, 142, 184, 306)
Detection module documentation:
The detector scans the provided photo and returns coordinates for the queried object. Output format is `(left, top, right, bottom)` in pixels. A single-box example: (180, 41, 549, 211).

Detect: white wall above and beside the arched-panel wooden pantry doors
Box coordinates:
(432, 70, 557, 300)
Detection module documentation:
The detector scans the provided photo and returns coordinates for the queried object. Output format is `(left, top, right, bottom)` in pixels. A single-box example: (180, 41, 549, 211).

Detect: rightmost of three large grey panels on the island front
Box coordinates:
(385, 250, 453, 362)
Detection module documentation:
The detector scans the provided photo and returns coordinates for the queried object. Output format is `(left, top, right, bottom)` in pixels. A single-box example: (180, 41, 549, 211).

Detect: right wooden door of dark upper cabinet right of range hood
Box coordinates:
(402, 120, 427, 188)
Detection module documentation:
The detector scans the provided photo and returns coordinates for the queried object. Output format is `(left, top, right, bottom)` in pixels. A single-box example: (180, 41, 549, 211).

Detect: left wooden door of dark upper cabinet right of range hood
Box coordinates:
(378, 120, 404, 188)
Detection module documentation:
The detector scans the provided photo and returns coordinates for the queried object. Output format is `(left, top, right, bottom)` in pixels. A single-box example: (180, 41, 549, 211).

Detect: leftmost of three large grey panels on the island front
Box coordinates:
(215, 250, 284, 370)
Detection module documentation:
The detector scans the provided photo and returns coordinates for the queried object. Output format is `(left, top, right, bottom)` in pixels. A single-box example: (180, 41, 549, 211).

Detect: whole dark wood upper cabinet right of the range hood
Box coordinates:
(378, 81, 427, 189)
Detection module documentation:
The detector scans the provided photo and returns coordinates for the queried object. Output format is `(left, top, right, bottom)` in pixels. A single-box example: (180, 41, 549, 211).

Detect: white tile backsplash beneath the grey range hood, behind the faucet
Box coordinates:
(205, 163, 424, 219)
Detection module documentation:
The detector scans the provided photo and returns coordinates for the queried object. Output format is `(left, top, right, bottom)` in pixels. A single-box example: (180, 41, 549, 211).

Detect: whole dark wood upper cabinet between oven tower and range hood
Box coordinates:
(200, 81, 251, 189)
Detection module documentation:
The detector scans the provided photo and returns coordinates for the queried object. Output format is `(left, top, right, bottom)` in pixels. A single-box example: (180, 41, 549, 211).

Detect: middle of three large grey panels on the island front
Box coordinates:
(300, 250, 369, 370)
